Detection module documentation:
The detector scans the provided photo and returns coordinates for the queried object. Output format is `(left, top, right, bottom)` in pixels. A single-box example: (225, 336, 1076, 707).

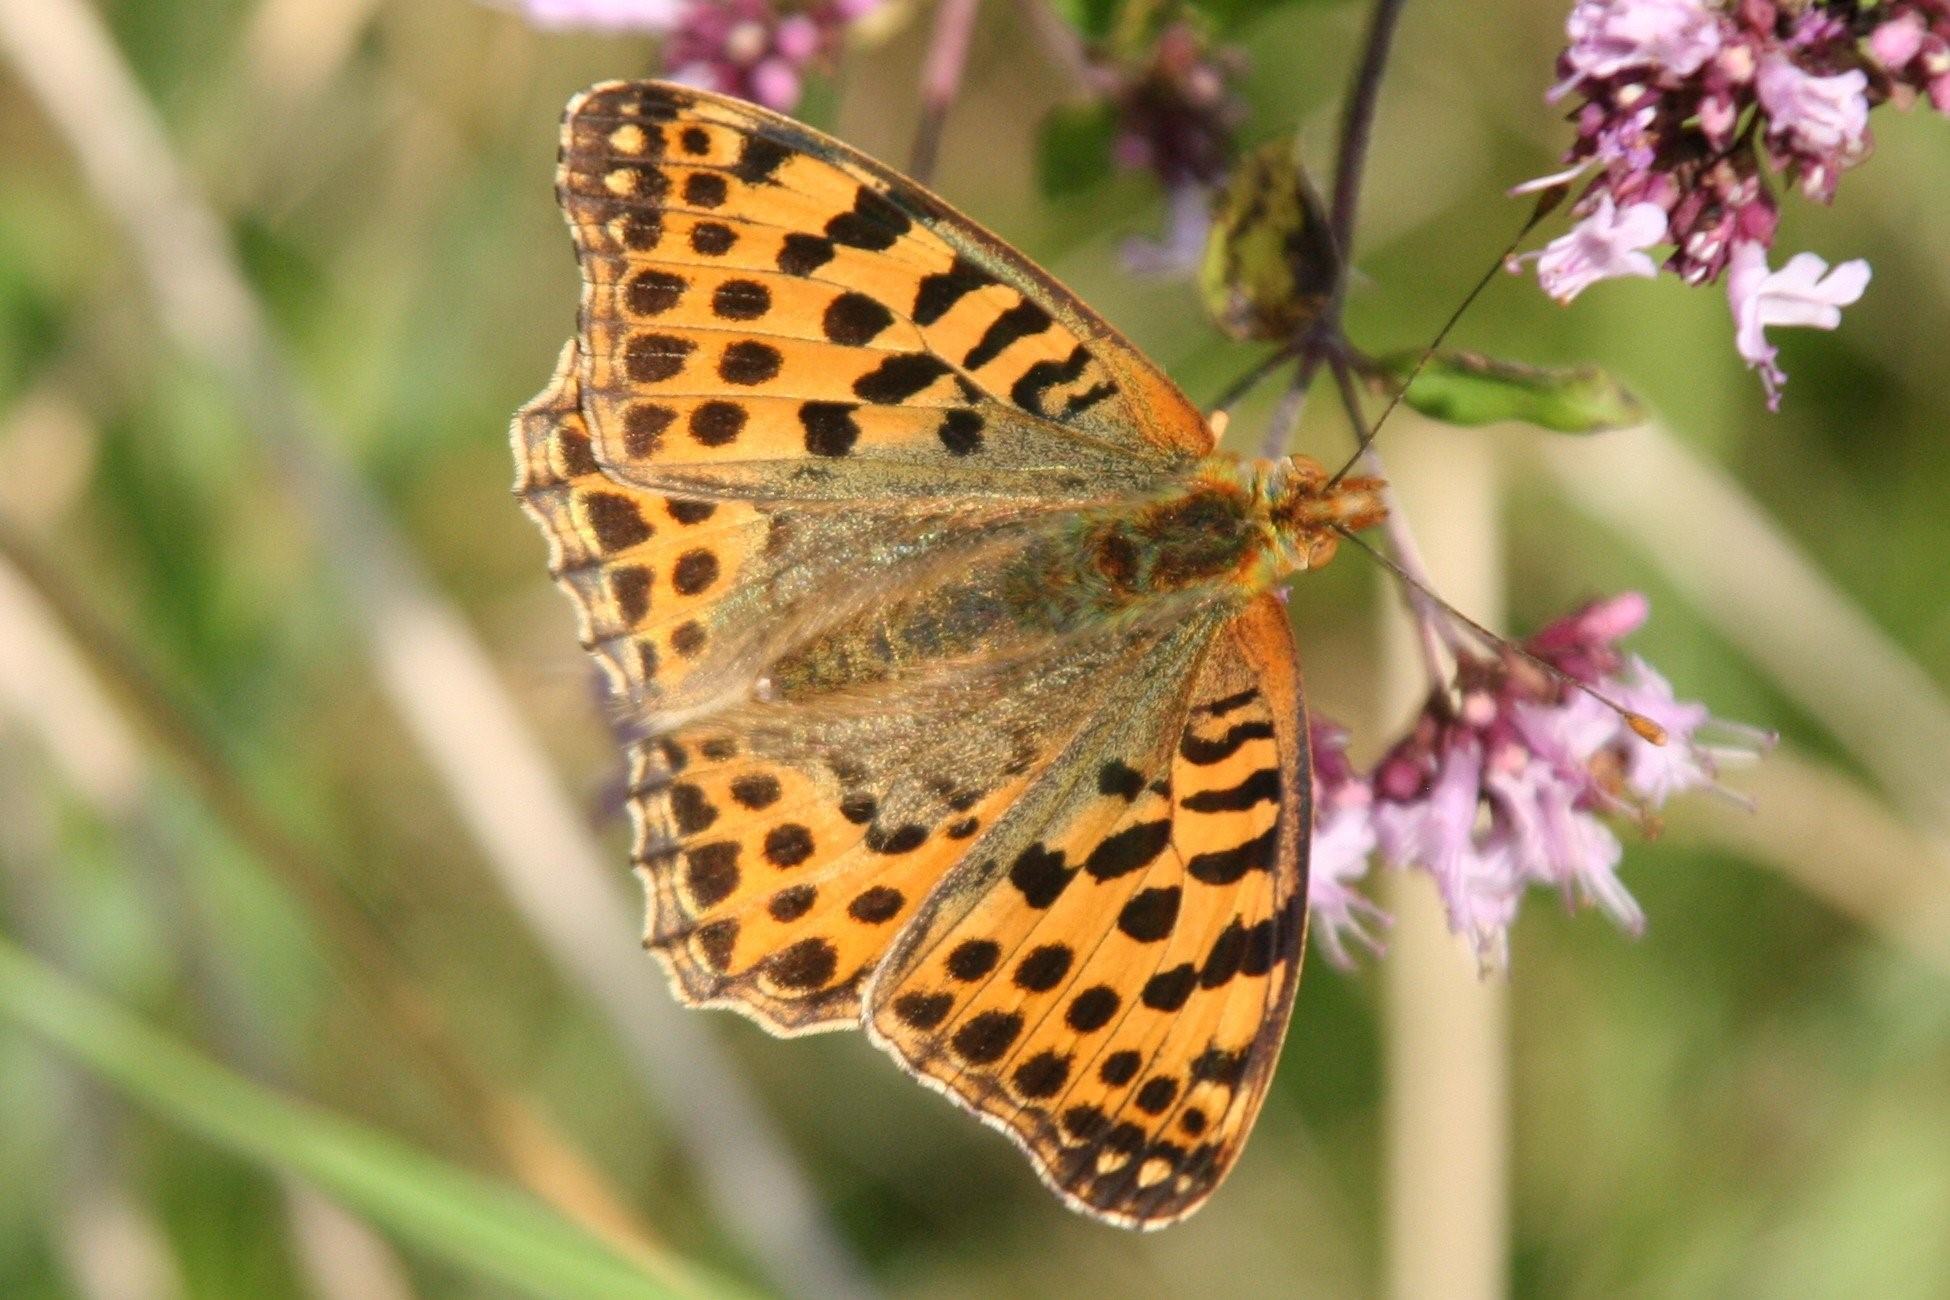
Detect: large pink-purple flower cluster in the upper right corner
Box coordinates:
(1519, 0, 1950, 407)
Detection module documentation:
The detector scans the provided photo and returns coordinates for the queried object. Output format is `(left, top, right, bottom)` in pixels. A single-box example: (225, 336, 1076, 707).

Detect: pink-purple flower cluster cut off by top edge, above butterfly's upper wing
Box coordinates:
(525, 0, 883, 113)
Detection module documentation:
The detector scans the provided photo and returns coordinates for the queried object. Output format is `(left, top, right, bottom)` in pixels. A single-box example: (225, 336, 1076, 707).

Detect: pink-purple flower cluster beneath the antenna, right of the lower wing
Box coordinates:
(1308, 593, 1767, 969)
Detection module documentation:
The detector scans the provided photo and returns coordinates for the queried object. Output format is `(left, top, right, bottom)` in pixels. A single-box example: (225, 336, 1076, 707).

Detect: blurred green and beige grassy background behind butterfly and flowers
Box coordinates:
(0, 0, 1950, 1296)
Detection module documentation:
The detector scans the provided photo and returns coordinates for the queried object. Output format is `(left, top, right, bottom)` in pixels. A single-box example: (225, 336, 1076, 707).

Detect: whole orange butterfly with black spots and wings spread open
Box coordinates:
(513, 82, 1381, 1228)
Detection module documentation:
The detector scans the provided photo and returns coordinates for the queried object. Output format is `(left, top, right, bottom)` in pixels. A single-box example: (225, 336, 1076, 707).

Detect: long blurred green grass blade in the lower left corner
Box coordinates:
(0, 937, 733, 1300)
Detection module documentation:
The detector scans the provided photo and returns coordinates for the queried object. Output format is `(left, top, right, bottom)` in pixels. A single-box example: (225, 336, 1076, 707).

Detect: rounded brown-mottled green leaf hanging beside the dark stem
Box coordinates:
(1199, 140, 1340, 341)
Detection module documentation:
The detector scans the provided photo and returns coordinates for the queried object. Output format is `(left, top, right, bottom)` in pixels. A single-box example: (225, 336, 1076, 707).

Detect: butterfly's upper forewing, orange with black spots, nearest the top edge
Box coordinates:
(558, 82, 1213, 501)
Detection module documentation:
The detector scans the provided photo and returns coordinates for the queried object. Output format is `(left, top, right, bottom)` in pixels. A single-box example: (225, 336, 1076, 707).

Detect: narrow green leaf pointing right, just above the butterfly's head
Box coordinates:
(1375, 351, 1646, 433)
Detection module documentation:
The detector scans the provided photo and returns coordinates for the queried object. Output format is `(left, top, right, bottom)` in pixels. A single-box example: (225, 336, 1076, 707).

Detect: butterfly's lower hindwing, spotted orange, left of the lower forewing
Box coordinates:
(634, 611, 1216, 1033)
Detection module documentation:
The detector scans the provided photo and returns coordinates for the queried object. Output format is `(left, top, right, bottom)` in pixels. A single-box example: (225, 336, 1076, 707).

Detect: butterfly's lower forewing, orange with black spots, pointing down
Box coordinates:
(868, 596, 1310, 1228)
